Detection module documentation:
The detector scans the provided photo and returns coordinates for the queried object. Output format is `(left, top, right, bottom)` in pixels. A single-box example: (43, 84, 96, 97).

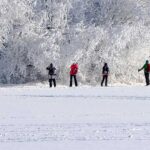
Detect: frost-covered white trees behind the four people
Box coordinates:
(0, 0, 150, 84)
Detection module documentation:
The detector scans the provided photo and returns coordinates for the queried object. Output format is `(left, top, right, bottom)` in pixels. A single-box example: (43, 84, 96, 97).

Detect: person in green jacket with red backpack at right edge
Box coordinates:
(138, 60, 150, 86)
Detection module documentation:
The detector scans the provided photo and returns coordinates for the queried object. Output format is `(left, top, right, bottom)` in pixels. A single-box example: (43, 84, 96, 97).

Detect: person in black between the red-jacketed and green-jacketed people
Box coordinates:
(101, 63, 109, 86)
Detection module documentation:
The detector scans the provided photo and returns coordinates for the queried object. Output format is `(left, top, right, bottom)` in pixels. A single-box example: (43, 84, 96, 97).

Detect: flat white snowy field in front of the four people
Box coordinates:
(0, 86, 150, 150)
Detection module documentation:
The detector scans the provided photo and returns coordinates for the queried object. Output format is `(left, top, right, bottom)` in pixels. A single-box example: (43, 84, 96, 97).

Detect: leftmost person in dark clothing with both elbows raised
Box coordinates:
(46, 63, 56, 87)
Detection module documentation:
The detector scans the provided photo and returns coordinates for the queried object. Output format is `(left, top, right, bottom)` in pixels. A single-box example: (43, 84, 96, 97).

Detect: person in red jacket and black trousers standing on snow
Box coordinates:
(70, 63, 78, 87)
